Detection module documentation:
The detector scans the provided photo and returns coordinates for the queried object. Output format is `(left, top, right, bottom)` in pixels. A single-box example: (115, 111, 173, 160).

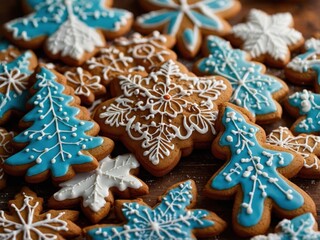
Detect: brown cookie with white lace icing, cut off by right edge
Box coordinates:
(267, 127, 320, 179)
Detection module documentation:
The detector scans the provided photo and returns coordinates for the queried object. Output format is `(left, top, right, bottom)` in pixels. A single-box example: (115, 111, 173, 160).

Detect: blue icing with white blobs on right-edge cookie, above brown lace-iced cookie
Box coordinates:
(288, 90, 320, 133)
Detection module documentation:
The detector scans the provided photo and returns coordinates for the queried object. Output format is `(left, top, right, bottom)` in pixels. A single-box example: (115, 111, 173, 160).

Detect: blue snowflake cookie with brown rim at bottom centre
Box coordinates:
(84, 180, 226, 240)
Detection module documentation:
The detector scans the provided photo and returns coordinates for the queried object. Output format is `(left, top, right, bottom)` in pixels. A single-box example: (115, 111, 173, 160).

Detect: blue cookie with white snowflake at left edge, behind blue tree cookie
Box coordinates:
(0, 47, 37, 125)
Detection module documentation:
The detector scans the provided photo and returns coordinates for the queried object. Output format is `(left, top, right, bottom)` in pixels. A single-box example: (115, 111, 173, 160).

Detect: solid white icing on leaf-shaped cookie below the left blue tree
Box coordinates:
(54, 154, 142, 212)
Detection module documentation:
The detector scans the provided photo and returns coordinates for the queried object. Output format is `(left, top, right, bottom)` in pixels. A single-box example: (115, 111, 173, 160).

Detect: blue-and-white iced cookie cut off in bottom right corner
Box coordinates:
(251, 213, 320, 240)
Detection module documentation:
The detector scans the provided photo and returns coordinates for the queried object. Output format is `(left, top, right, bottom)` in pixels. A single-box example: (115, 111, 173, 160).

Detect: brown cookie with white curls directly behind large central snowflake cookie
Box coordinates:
(83, 31, 177, 85)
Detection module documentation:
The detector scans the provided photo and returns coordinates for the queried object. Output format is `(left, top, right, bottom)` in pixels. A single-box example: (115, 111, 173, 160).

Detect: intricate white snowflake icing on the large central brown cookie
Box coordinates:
(96, 60, 228, 165)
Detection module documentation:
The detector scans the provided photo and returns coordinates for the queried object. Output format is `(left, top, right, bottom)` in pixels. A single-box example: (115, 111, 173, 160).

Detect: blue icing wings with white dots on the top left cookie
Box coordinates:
(6, 0, 131, 40)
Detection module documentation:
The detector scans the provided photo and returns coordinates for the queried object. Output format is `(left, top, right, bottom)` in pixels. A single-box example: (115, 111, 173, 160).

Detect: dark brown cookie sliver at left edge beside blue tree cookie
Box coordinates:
(0, 128, 14, 189)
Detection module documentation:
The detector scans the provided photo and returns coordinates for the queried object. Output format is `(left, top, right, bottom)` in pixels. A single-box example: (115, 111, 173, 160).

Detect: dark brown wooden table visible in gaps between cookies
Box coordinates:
(0, 0, 320, 239)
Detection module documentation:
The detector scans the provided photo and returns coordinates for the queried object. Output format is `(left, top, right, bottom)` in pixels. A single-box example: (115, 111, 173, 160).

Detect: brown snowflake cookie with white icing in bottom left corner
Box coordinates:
(0, 187, 81, 240)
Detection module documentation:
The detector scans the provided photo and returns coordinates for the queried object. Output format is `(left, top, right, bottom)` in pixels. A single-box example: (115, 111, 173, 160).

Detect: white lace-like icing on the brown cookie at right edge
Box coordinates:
(267, 127, 320, 169)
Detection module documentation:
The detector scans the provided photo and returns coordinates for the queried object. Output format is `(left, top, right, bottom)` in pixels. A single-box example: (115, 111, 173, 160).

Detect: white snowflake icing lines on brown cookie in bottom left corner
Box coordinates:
(0, 193, 68, 240)
